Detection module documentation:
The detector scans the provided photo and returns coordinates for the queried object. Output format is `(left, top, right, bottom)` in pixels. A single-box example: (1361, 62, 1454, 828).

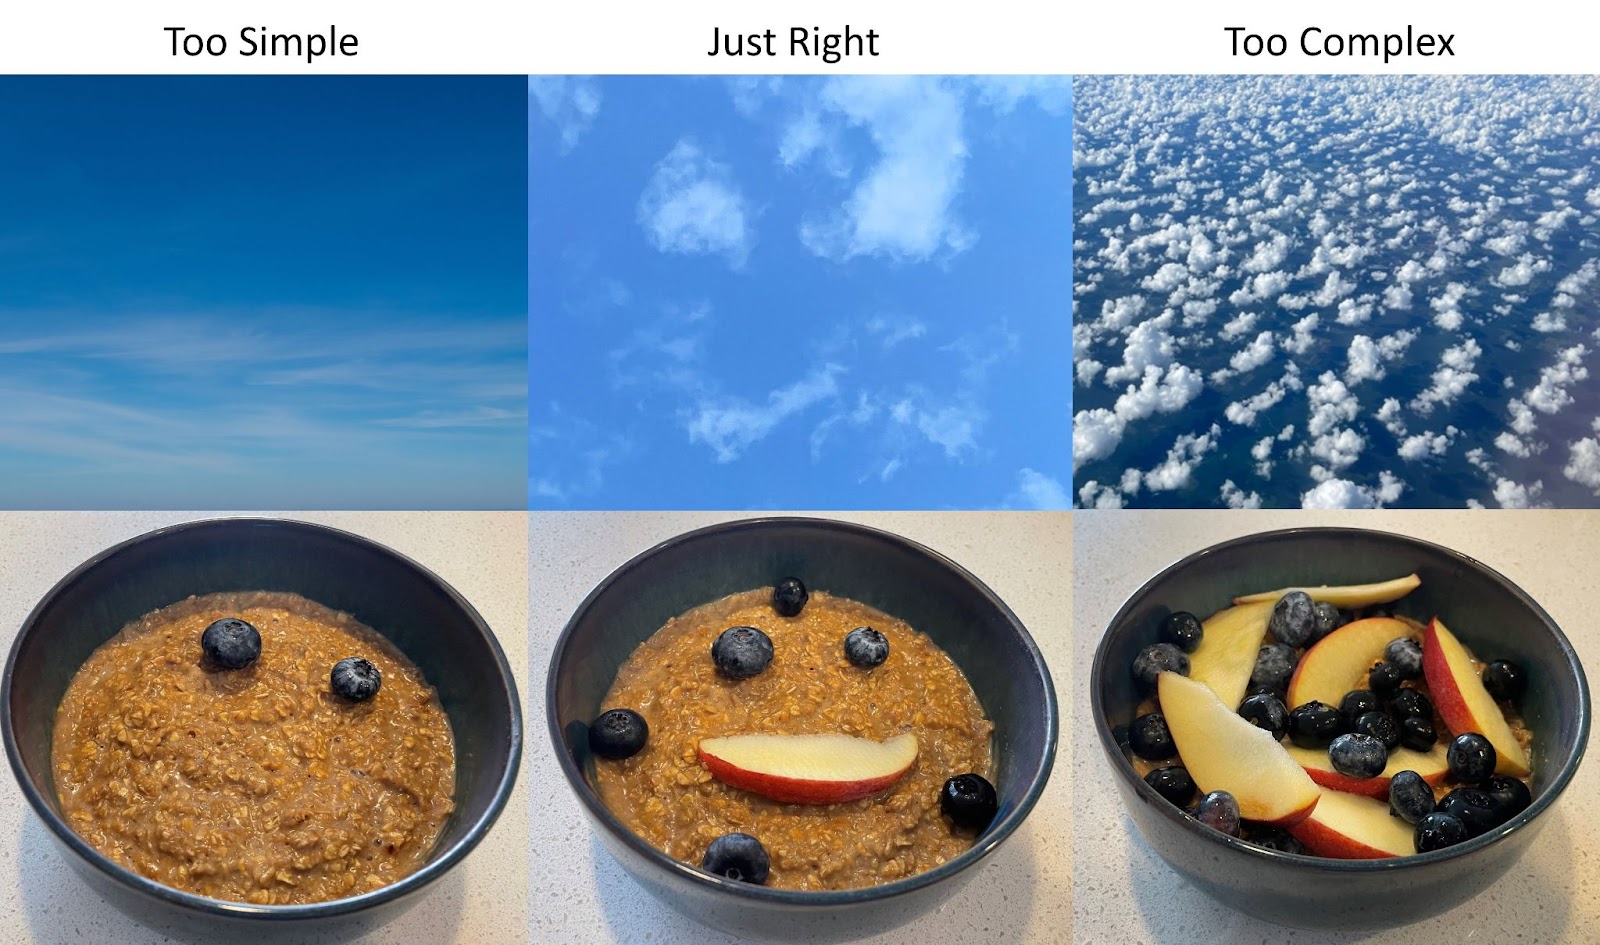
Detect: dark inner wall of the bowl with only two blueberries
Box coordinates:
(6, 520, 522, 910)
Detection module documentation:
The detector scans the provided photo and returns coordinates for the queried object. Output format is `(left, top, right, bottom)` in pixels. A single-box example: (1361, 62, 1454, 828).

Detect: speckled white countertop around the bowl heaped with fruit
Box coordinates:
(1058, 510, 1600, 945)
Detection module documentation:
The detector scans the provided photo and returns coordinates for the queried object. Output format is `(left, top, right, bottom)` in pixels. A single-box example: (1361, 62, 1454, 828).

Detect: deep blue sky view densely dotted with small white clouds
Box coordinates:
(1072, 77, 1600, 508)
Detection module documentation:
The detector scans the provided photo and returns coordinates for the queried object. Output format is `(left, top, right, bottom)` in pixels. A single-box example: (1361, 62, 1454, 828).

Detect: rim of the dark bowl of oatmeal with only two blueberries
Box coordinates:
(0, 515, 523, 921)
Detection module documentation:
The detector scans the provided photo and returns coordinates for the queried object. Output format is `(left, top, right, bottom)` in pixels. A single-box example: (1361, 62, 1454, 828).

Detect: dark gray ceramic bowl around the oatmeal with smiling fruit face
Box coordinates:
(547, 518, 1056, 942)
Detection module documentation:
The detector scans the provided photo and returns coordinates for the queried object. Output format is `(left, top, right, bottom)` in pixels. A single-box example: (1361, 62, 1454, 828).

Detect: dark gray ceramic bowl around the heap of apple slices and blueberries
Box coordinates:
(1090, 528, 1590, 931)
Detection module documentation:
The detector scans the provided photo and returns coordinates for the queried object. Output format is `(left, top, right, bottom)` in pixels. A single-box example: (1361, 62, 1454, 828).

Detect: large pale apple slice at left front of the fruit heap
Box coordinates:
(1157, 673, 1318, 825)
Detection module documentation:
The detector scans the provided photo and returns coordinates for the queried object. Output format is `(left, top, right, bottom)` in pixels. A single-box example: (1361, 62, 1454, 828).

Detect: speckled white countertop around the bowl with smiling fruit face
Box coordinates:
(523, 512, 1072, 945)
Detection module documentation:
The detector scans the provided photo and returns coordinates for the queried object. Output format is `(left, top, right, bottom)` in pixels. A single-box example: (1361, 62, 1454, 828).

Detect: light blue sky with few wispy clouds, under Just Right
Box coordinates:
(528, 77, 1072, 508)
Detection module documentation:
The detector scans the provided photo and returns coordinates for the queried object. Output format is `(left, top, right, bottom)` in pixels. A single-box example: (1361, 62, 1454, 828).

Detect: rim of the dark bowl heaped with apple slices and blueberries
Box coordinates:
(1090, 526, 1592, 873)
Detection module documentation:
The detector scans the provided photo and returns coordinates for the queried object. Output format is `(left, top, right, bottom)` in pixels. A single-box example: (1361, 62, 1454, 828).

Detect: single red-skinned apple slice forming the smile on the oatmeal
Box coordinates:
(699, 732, 917, 804)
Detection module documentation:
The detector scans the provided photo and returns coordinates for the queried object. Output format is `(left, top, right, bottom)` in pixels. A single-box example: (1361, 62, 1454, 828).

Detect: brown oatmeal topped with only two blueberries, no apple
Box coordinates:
(53, 593, 454, 905)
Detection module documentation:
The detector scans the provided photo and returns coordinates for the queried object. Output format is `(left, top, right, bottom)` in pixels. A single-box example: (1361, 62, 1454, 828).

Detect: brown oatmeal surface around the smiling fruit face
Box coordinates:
(595, 588, 994, 889)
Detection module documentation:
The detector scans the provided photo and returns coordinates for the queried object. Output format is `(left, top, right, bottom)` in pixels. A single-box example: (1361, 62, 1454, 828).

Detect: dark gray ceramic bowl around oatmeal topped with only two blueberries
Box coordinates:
(0, 518, 522, 942)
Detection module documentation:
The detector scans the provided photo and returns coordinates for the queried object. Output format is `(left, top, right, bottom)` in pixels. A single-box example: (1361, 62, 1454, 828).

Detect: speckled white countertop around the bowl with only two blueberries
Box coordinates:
(0, 512, 533, 945)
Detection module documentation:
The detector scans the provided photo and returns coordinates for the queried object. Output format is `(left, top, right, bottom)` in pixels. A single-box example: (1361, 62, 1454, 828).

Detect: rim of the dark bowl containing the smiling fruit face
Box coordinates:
(544, 515, 1059, 910)
